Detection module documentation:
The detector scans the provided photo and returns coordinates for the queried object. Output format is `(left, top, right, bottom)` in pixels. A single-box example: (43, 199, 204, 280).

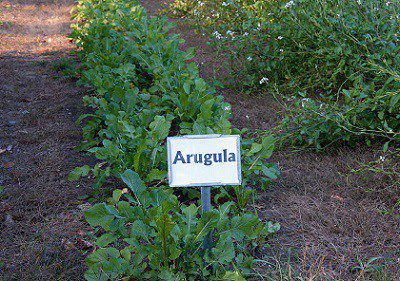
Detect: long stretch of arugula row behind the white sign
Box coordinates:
(70, 1, 278, 188)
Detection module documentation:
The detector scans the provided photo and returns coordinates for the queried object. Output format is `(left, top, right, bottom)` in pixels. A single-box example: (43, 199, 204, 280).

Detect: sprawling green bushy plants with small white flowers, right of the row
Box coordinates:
(171, 0, 400, 148)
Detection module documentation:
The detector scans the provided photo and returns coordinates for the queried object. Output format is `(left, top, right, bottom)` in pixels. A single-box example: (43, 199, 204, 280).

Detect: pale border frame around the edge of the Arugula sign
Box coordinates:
(167, 134, 242, 187)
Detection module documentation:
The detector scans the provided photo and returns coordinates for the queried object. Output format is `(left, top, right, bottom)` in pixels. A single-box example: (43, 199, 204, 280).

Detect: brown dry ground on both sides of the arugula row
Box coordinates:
(0, 0, 400, 280)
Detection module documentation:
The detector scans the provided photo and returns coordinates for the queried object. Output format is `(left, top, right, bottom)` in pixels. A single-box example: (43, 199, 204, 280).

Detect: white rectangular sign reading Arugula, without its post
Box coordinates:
(167, 135, 242, 186)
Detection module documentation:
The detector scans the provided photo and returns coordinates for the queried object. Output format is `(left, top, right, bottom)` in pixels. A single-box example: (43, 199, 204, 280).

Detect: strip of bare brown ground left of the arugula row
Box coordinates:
(0, 1, 91, 280)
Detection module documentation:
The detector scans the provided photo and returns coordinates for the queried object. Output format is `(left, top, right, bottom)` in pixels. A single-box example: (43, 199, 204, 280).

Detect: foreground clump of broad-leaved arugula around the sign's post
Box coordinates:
(85, 170, 279, 280)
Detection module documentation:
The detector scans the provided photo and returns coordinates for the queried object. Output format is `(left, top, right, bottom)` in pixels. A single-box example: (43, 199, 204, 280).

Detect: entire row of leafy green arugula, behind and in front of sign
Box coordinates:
(70, 0, 279, 280)
